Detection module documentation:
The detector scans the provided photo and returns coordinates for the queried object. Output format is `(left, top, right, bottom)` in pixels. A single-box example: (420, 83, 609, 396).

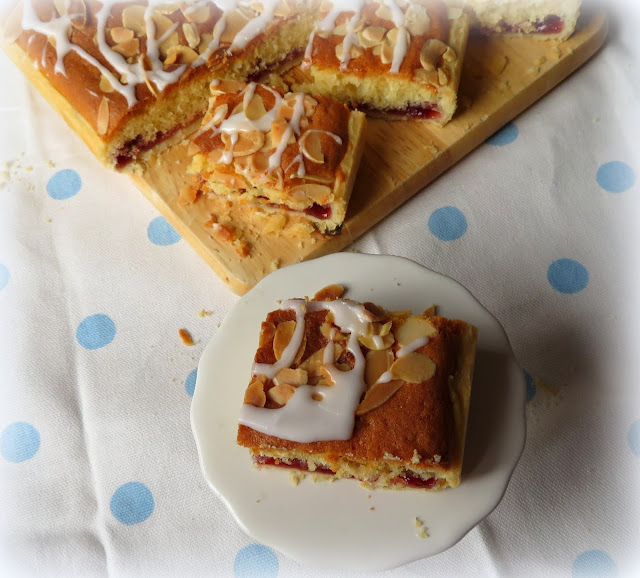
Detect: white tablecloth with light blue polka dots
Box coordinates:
(0, 5, 640, 578)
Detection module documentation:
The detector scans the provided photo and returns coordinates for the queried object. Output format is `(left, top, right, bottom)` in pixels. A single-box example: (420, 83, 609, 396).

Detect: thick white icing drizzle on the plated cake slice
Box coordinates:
(244, 299, 372, 443)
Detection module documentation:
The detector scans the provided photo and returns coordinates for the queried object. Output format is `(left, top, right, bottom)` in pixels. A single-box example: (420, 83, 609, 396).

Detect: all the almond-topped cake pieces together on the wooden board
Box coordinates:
(3, 0, 580, 234)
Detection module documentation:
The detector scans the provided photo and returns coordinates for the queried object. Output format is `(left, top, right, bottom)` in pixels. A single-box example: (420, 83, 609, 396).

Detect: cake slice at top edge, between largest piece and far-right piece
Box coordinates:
(302, 0, 469, 125)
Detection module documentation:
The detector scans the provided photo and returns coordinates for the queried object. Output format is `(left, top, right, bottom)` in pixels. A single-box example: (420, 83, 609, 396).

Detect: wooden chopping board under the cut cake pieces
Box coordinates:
(133, 11, 607, 294)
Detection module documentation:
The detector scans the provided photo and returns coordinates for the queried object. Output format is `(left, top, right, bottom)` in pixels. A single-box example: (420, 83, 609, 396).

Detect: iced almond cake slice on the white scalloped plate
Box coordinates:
(237, 285, 477, 490)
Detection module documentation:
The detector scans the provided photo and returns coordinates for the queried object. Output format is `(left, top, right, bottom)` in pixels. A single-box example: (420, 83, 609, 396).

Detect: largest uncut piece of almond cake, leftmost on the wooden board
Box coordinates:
(5, 0, 314, 170)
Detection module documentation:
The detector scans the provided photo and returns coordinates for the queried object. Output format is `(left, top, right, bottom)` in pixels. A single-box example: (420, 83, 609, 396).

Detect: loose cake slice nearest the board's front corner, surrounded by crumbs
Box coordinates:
(190, 80, 366, 235)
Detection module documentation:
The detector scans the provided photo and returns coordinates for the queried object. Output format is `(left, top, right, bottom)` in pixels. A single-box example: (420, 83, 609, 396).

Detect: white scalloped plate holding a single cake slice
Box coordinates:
(191, 253, 525, 571)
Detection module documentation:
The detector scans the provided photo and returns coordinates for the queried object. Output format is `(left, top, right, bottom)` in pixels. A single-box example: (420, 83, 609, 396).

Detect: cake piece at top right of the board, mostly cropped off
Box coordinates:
(467, 0, 581, 40)
